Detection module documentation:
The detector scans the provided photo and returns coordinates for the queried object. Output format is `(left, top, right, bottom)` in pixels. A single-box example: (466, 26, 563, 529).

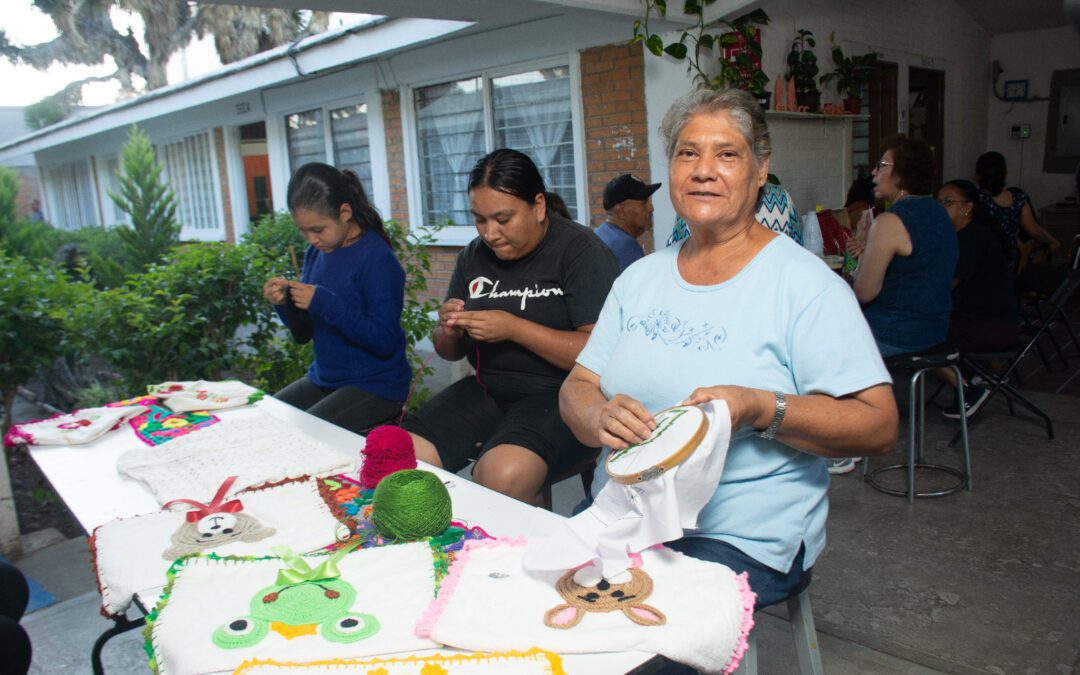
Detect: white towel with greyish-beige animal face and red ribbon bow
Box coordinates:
(91, 478, 338, 617)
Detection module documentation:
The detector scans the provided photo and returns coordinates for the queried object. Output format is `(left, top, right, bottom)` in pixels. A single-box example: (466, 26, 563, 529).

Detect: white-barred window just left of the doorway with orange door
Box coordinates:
(158, 132, 221, 231)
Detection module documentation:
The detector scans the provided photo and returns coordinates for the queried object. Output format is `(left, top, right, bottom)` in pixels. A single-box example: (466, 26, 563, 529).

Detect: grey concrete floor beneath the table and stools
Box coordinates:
(8, 345, 1080, 675)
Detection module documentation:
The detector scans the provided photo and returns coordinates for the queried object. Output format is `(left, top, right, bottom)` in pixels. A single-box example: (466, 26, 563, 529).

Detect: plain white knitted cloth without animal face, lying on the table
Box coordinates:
(117, 410, 355, 504)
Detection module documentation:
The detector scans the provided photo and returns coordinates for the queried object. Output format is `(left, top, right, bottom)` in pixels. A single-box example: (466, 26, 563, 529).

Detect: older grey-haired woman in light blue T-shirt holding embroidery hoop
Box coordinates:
(561, 89, 897, 607)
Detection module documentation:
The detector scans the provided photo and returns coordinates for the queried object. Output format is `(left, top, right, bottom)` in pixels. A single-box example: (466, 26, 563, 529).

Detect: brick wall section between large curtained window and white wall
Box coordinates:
(581, 43, 654, 253)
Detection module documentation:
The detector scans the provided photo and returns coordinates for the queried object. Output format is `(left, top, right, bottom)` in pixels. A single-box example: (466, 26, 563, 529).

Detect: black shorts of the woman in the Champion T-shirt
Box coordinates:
(402, 377, 596, 477)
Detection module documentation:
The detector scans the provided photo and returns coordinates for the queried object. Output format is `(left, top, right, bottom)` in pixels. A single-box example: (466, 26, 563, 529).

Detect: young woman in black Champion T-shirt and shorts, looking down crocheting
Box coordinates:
(402, 149, 619, 504)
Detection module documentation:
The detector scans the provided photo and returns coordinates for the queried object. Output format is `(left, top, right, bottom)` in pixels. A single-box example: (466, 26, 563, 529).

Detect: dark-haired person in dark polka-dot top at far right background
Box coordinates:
(975, 152, 1062, 269)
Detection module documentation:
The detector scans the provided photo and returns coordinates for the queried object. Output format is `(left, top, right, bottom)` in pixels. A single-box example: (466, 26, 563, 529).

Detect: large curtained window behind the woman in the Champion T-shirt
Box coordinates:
(414, 66, 578, 225)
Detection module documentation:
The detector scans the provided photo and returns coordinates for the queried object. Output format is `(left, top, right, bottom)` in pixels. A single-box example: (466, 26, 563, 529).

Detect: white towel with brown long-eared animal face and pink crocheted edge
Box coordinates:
(417, 540, 754, 673)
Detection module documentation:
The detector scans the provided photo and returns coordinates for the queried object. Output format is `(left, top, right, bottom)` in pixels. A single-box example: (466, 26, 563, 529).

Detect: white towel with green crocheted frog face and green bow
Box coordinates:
(147, 543, 436, 675)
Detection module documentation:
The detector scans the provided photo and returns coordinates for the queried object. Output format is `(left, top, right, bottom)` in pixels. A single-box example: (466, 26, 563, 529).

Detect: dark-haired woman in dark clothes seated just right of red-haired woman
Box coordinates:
(937, 180, 1020, 419)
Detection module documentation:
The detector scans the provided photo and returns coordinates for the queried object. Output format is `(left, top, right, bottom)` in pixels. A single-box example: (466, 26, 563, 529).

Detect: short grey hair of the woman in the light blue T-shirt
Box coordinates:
(660, 89, 772, 166)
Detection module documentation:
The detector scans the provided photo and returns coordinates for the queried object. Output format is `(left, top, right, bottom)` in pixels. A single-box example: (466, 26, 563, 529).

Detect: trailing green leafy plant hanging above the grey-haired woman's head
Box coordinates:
(634, 0, 771, 107)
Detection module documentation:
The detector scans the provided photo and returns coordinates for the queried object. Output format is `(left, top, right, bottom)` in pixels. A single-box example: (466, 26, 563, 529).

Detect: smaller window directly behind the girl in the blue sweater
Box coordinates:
(285, 103, 373, 201)
